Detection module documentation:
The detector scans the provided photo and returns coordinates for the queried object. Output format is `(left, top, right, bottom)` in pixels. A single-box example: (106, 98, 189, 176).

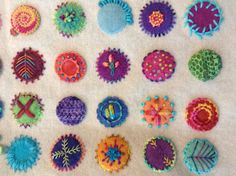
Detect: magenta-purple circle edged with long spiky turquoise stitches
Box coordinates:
(184, 0, 223, 39)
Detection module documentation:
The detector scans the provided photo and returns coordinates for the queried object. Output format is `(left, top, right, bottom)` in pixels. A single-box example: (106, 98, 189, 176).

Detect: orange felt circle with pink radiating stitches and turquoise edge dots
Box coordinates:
(141, 96, 176, 128)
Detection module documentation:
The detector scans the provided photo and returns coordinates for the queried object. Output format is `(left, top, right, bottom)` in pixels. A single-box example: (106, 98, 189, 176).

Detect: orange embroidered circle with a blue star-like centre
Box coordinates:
(96, 135, 130, 172)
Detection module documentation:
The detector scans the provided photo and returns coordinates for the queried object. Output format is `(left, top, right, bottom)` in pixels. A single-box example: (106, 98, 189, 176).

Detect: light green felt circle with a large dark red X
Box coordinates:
(11, 93, 43, 128)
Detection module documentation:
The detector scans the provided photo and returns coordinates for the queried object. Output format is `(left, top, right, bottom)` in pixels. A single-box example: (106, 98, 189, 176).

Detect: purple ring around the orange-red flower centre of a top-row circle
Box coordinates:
(139, 1, 176, 37)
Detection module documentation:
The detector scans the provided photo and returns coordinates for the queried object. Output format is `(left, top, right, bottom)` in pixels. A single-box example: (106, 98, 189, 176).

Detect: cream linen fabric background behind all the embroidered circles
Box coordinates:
(0, 0, 236, 176)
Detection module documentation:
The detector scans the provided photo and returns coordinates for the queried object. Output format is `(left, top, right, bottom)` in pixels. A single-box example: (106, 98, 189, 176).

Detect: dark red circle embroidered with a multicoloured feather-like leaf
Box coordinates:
(12, 48, 45, 84)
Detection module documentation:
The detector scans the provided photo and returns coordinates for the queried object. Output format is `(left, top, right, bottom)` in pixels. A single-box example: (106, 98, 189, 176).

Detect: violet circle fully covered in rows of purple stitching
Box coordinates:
(56, 96, 87, 125)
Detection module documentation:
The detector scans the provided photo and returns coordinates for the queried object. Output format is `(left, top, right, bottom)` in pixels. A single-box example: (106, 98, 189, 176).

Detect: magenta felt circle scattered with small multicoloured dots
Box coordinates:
(142, 50, 176, 82)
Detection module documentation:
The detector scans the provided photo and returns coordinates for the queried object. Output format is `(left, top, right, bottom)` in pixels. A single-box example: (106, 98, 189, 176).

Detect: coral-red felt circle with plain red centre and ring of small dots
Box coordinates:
(55, 52, 87, 82)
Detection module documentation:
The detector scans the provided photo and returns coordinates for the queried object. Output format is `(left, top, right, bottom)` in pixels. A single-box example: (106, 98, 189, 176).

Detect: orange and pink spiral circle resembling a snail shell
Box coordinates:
(11, 5, 41, 36)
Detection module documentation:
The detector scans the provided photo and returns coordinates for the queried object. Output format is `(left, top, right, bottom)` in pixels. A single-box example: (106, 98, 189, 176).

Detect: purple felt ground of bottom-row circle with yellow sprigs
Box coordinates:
(145, 138, 175, 170)
